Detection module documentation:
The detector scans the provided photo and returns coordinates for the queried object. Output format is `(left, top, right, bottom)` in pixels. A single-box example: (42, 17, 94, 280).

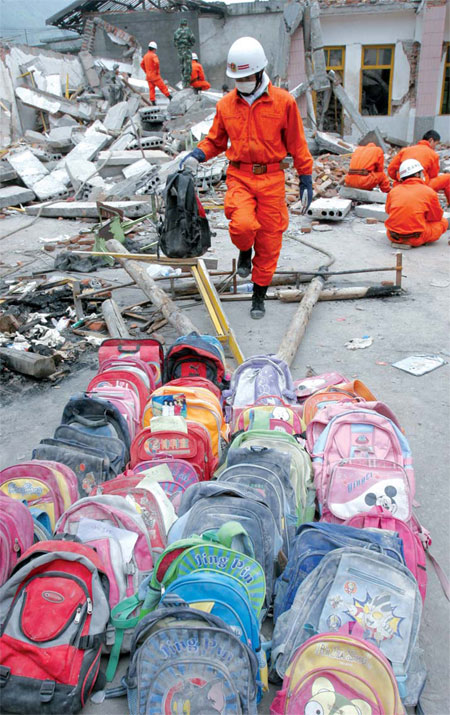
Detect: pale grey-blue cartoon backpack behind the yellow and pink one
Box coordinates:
(271, 547, 426, 706)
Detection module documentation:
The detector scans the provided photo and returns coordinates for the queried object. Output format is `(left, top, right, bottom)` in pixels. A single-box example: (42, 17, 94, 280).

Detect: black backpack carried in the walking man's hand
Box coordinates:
(158, 169, 211, 258)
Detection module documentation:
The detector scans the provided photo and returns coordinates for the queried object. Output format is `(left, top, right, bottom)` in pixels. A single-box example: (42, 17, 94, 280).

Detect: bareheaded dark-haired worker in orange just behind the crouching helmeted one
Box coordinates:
(388, 129, 450, 206)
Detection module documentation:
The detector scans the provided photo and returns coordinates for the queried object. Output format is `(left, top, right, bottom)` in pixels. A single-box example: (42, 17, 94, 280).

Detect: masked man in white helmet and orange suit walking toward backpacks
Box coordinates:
(180, 37, 313, 319)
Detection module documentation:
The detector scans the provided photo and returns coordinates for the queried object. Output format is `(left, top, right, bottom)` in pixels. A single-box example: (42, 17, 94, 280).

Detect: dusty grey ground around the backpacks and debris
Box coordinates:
(0, 206, 450, 715)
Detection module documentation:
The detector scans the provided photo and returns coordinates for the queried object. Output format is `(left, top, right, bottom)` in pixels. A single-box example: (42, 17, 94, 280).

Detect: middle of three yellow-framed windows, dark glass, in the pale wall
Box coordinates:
(361, 45, 394, 115)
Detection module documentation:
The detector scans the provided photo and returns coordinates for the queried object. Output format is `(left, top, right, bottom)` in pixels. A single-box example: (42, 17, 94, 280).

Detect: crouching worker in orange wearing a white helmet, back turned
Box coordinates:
(385, 159, 448, 248)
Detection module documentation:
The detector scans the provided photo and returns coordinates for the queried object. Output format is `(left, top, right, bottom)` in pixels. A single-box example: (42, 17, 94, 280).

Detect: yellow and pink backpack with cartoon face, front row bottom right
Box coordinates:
(270, 623, 405, 715)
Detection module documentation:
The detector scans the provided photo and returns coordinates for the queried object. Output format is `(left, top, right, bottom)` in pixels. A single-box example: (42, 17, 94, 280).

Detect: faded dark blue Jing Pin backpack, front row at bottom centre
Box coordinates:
(119, 602, 258, 715)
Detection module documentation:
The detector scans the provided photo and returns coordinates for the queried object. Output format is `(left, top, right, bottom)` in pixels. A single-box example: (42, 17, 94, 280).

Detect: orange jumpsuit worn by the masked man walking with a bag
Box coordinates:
(198, 83, 313, 286)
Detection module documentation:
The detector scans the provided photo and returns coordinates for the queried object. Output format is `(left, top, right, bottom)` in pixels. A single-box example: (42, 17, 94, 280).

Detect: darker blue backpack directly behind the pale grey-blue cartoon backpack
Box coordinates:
(273, 522, 405, 621)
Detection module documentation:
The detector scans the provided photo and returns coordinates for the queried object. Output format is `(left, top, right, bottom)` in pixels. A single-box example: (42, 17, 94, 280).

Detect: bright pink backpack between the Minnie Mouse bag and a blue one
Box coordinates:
(344, 506, 431, 601)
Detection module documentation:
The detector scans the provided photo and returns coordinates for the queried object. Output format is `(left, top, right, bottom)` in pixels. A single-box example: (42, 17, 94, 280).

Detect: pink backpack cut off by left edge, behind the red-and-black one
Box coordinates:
(0, 493, 34, 586)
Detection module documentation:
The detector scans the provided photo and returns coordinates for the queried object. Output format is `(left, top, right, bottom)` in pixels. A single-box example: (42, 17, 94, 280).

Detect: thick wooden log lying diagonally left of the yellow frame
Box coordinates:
(106, 238, 200, 335)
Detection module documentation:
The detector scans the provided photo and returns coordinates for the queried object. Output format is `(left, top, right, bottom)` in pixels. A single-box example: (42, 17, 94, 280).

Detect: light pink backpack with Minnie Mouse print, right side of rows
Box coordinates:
(312, 409, 415, 507)
